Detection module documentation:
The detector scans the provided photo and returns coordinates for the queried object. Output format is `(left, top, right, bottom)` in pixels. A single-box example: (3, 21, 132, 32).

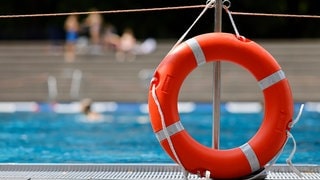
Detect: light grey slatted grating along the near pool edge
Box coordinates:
(0, 164, 320, 180)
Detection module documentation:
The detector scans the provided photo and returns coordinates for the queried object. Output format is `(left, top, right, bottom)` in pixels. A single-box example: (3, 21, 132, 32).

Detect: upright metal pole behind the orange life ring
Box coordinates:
(212, 0, 222, 149)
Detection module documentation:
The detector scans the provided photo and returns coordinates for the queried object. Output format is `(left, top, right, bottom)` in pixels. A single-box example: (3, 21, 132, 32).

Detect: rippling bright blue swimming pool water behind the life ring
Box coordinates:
(0, 103, 320, 164)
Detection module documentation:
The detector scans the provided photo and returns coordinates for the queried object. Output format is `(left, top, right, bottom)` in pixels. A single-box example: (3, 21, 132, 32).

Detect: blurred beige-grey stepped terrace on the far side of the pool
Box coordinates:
(0, 39, 320, 102)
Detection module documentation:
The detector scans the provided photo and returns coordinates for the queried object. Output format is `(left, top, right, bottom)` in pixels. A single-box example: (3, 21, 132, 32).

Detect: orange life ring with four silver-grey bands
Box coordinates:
(148, 33, 293, 179)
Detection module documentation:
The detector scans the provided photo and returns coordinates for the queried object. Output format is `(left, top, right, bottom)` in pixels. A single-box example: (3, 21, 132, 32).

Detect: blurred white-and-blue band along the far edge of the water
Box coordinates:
(0, 101, 312, 114)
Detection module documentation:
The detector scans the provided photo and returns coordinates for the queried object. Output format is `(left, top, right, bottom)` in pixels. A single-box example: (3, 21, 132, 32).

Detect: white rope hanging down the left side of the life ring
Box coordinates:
(151, 83, 188, 179)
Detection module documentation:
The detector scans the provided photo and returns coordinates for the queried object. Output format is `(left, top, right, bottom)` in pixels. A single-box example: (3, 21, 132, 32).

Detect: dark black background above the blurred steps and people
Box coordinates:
(0, 0, 320, 40)
